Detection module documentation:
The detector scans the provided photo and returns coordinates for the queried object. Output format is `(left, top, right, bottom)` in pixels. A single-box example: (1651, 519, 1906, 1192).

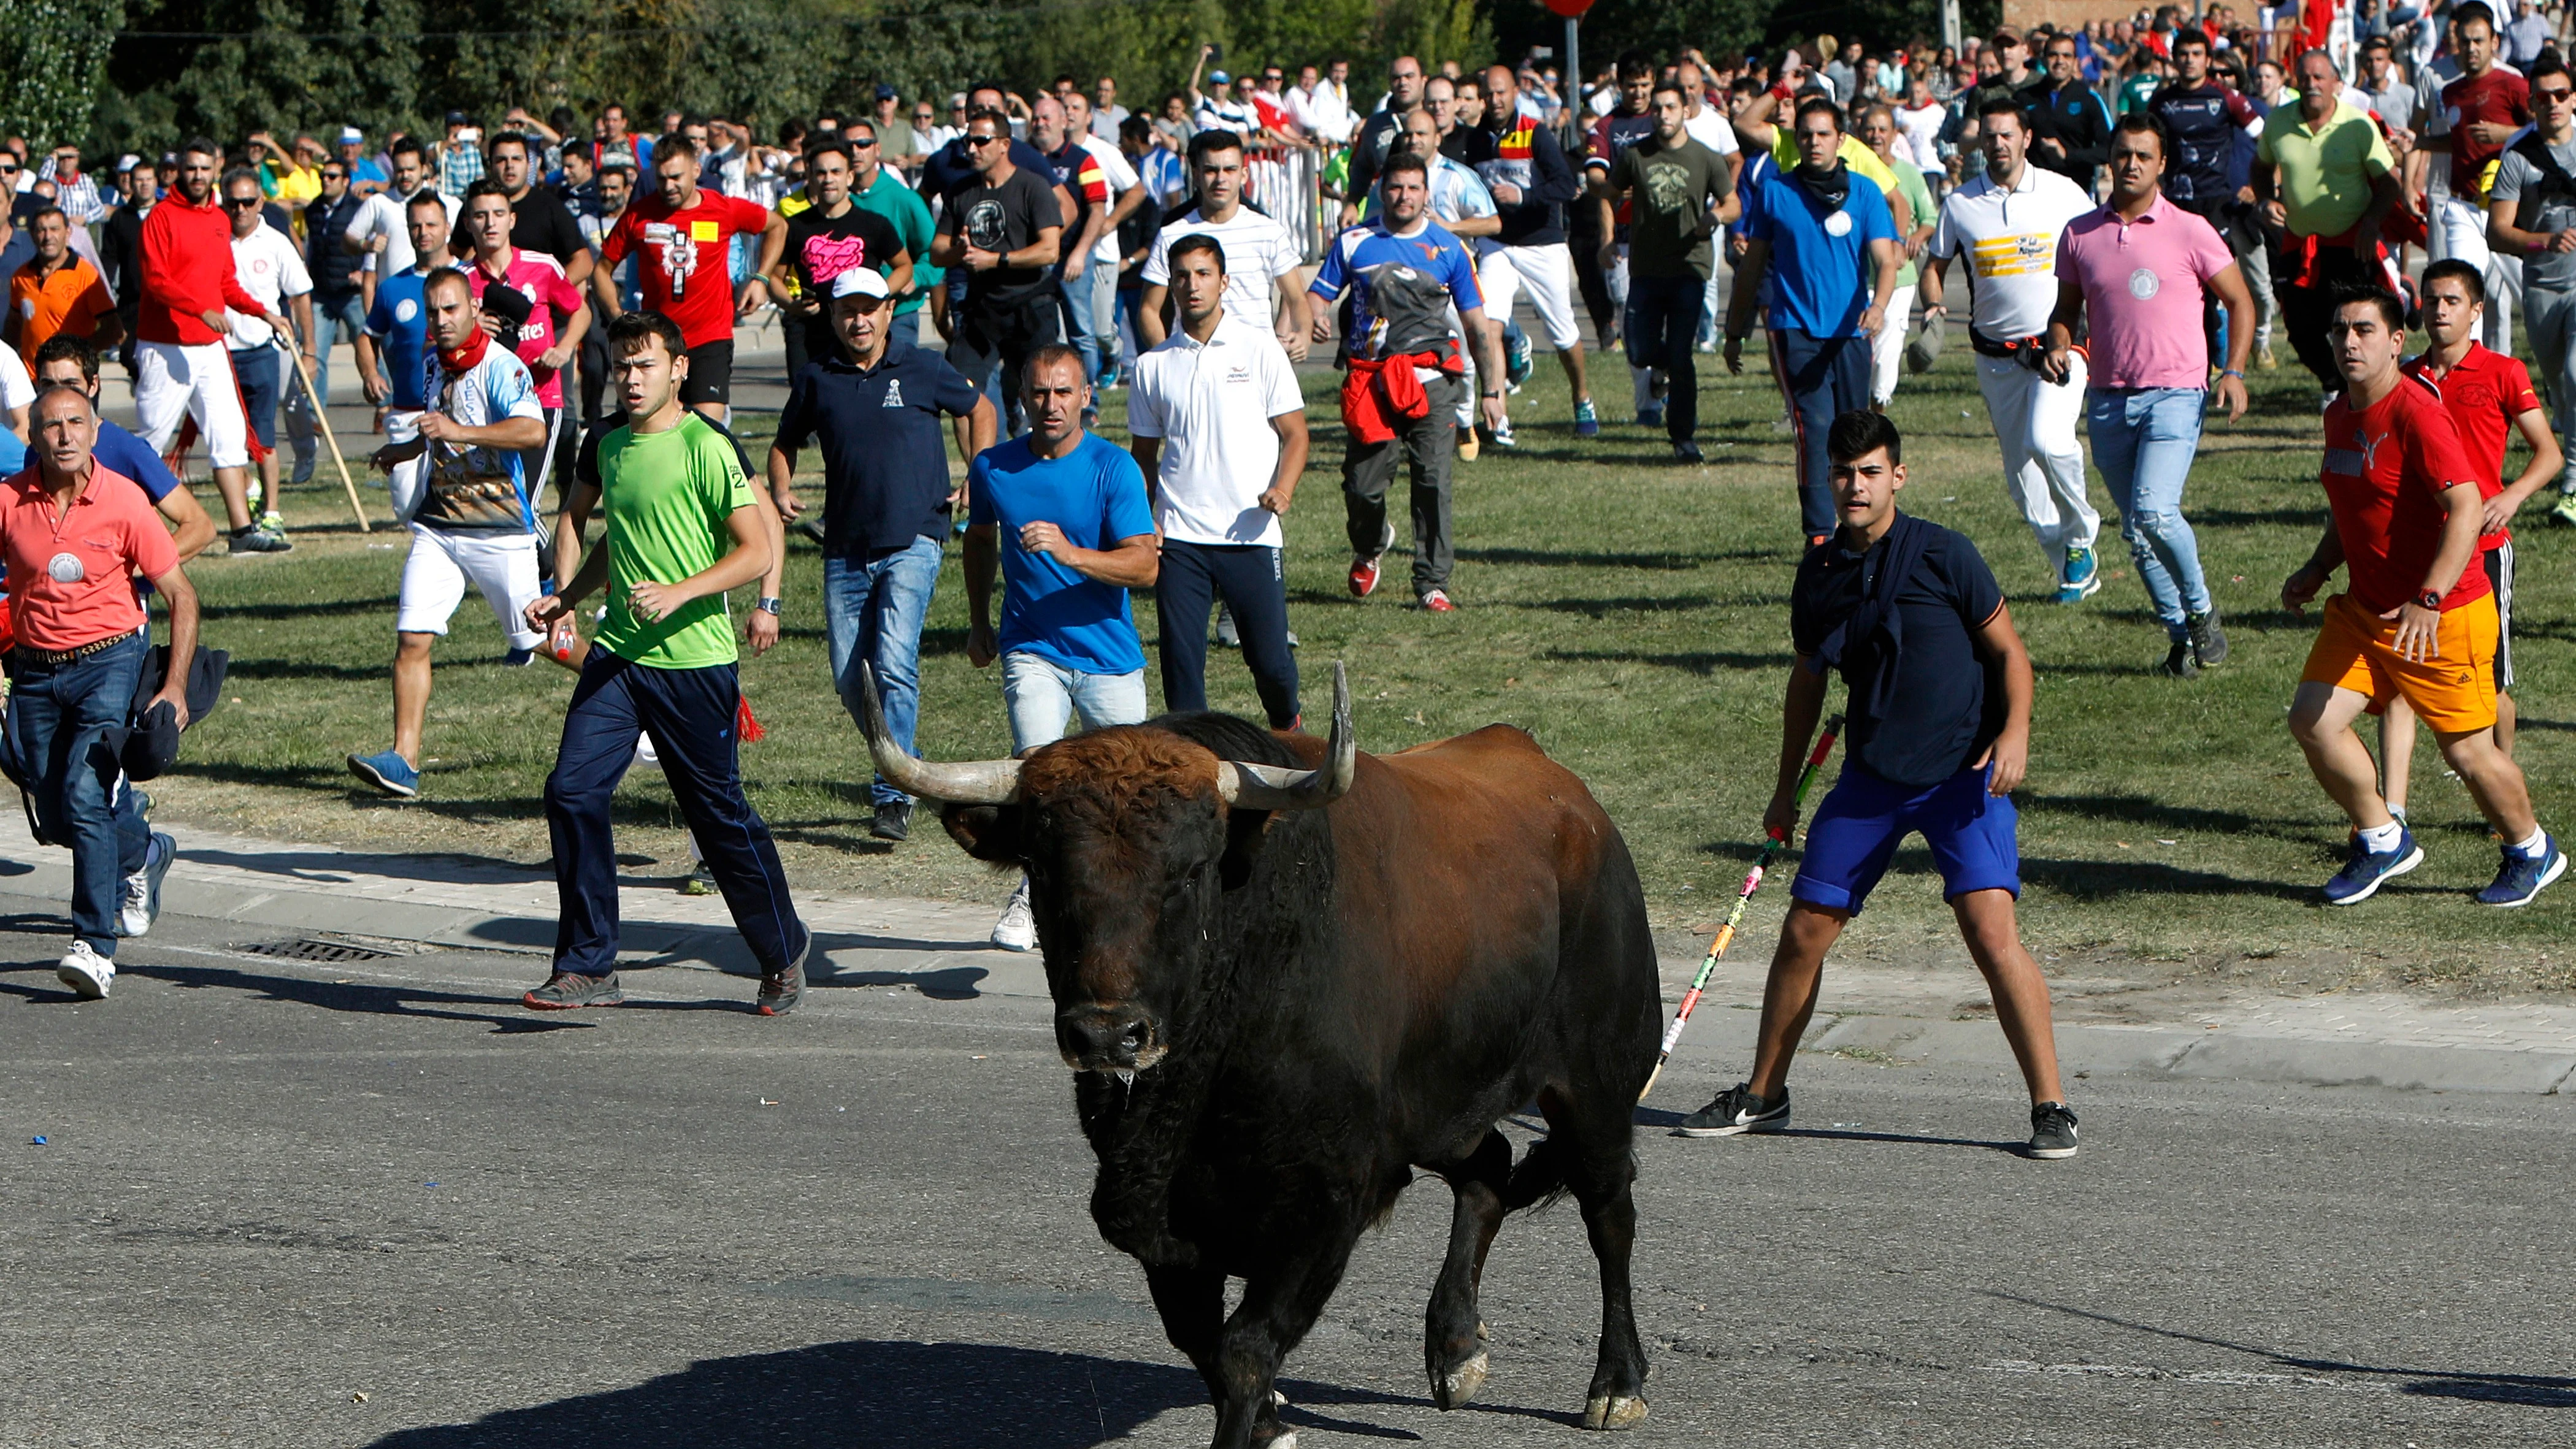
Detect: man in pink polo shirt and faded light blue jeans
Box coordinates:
(2040, 110, 2254, 679)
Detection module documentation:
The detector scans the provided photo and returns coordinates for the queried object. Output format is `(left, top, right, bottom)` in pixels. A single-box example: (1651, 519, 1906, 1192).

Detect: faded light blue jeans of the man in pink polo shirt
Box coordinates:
(2084, 389, 2210, 643)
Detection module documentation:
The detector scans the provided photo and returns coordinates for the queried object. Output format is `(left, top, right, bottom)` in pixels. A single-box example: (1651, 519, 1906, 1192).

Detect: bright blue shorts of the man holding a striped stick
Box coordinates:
(1788, 765, 2022, 914)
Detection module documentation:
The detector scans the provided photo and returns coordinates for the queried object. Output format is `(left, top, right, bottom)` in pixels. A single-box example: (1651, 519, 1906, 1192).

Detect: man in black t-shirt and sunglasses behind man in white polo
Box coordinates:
(930, 110, 1064, 435)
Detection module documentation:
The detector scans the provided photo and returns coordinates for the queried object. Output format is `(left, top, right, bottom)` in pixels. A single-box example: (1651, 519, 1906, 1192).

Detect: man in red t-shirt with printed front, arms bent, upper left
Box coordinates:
(590, 134, 788, 422)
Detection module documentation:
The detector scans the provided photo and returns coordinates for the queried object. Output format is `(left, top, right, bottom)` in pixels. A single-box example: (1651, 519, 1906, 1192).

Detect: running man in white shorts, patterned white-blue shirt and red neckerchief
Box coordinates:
(348, 266, 546, 800)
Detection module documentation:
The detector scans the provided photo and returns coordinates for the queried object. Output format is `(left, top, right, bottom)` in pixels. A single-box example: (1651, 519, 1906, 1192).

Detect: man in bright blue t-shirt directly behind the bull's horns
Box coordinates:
(966, 342, 1162, 950)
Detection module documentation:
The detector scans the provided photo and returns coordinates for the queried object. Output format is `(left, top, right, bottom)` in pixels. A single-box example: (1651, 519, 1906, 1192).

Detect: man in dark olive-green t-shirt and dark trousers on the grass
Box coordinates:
(1608, 80, 1736, 463)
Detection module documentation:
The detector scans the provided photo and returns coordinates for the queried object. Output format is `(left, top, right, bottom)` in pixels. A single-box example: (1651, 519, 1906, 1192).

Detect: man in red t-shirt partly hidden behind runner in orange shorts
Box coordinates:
(2380, 258, 2561, 821)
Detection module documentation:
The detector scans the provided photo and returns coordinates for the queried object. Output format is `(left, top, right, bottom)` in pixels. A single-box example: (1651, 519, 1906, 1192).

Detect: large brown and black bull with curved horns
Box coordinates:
(863, 667, 1662, 1449)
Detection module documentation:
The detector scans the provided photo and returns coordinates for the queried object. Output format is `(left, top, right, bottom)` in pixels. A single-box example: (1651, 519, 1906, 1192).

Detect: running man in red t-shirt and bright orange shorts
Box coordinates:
(2280, 288, 2566, 906)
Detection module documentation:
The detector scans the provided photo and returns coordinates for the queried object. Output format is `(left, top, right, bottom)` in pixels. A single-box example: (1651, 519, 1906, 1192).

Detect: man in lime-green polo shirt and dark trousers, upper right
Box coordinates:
(2254, 52, 2398, 396)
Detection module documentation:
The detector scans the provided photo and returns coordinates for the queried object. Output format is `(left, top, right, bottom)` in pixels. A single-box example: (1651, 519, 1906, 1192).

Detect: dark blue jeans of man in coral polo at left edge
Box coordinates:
(8, 633, 152, 957)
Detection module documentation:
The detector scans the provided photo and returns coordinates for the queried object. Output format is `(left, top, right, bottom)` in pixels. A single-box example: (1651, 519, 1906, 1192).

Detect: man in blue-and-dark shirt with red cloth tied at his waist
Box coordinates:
(1306, 152, 1507, 613)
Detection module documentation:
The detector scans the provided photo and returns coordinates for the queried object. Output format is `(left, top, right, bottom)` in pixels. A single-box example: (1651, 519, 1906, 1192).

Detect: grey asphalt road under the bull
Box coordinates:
(0, 916, 2576, 1449)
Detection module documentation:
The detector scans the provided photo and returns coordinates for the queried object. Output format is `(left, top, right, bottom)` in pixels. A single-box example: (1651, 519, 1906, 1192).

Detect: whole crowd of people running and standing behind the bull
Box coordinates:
(0, 0, 2576, 1153)
